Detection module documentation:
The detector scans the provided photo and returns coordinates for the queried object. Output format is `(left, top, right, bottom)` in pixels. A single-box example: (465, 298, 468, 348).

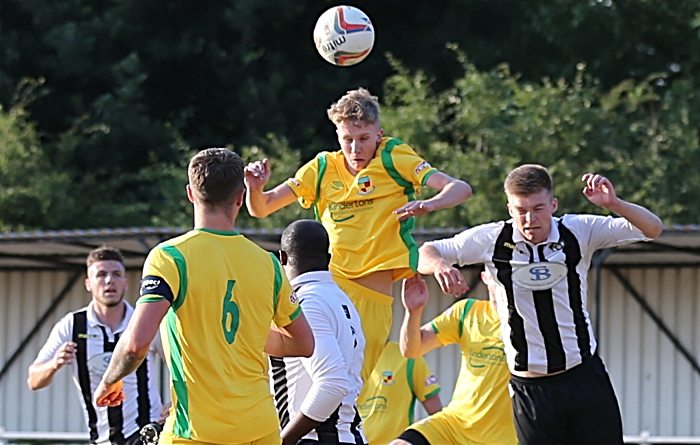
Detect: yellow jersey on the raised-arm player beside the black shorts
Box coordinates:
(416, 299, 518, 445)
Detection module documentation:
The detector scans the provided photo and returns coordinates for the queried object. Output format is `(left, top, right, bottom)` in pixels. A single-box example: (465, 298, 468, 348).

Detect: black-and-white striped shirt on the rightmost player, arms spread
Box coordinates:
(429, 215, 649, 374)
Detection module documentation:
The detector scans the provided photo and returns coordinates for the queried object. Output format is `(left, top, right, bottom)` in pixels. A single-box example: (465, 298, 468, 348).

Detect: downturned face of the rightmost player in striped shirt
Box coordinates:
(507, 190, 557, 244)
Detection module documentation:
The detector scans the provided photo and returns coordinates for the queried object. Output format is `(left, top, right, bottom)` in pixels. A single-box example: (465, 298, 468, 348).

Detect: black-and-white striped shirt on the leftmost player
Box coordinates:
(34, 302, 163, 444)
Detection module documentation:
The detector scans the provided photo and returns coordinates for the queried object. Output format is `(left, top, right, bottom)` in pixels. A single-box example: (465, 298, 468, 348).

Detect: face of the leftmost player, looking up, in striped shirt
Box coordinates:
(85, 260, 128, 307)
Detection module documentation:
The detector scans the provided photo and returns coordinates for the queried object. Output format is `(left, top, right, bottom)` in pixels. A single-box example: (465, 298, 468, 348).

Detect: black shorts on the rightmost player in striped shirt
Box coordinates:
(510, 354, 623, 445)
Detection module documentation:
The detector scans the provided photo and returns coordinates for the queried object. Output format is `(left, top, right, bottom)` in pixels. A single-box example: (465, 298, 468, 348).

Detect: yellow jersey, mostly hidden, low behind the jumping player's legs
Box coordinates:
(357, 342, 440, 445)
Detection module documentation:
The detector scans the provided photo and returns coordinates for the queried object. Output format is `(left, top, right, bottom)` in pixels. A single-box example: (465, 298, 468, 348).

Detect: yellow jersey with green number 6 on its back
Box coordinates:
(139, 229, 301, 444)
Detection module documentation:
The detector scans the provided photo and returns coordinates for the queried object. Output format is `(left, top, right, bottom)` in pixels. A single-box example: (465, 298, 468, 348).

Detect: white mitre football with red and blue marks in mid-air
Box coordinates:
(314, 6, 374, 66)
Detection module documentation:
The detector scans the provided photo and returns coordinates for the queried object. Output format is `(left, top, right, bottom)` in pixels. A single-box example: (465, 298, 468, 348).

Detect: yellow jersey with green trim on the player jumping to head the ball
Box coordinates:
(286, 138, 437, 281)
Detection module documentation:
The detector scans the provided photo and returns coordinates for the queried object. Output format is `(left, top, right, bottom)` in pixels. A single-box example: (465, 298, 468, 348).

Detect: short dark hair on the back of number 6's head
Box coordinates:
(187, 148, 245, 207)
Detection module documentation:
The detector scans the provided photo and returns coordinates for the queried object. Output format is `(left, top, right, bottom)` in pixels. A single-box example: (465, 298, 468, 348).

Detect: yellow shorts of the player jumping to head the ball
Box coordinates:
(333, 275, 394, 382)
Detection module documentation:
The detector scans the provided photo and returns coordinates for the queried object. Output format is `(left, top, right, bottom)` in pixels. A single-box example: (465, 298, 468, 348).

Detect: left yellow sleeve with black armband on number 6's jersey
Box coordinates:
(136, 246, 180, 305)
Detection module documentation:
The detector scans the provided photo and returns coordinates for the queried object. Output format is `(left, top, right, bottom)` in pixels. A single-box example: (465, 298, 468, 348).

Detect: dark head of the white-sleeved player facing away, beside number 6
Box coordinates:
(280, 219, 330, 272)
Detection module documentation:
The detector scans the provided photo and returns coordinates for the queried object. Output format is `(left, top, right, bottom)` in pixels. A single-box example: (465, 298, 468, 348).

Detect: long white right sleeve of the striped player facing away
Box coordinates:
(300, 298, 350, 422)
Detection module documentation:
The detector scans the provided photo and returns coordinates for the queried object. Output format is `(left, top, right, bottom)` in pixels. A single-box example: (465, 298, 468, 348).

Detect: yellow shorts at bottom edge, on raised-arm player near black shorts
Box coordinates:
(408, 409, 518, 445)
